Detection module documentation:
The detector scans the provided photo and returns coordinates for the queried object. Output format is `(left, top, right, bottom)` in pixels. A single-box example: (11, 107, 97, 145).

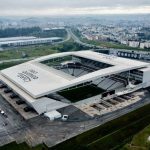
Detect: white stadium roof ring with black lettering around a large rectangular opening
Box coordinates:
(1, 51, 149, 98)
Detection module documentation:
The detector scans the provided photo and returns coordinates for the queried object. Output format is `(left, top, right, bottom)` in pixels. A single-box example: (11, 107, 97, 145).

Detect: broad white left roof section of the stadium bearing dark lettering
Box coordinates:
(1, 63, 69, 98)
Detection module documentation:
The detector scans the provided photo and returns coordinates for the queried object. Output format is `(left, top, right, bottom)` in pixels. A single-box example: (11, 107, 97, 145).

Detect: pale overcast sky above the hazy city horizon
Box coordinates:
(0, 0, 150, 16)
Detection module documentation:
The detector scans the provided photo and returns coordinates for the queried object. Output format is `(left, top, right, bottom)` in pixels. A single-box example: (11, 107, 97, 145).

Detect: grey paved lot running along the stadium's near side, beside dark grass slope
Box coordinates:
(0, 86, 150, 146)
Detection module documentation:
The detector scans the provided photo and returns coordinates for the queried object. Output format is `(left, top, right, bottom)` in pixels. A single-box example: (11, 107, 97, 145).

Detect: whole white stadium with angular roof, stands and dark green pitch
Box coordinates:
(0, 51, 150, 118)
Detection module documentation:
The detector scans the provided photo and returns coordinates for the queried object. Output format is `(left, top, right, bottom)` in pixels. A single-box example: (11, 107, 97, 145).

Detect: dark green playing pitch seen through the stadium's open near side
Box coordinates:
(58, 85, 104, 102)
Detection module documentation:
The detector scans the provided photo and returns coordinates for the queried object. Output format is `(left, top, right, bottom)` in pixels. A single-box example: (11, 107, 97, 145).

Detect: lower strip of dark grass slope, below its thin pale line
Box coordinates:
(88, 111, 150, 150)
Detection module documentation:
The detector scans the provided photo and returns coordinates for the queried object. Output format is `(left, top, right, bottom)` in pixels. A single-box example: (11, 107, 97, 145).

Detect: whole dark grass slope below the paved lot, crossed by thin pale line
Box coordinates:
(51, 101, 150, 150)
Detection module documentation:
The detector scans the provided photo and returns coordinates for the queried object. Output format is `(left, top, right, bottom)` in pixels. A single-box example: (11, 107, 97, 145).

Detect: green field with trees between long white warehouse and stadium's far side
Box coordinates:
(0, 40, 88, 60)
